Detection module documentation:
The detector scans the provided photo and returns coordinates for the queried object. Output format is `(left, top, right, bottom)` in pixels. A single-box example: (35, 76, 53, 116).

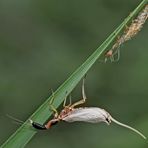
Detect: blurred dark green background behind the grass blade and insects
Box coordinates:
(0, 0, 148, 148)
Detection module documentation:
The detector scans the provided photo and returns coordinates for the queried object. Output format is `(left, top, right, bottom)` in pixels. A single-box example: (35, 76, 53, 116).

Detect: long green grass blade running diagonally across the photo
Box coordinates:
(1, 0, 148, 148)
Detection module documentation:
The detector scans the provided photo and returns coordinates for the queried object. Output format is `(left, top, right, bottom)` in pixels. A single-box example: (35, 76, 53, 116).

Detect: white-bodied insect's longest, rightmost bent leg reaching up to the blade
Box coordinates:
(71, 78, 86, 108)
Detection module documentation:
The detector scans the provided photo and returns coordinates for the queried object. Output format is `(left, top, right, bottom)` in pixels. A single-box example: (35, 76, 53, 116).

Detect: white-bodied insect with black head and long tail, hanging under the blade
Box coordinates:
(30, 79, 146, 139)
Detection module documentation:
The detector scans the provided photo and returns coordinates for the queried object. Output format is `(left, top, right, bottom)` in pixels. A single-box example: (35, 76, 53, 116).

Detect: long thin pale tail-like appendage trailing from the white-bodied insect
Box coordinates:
(110, 116, 146, 139)
